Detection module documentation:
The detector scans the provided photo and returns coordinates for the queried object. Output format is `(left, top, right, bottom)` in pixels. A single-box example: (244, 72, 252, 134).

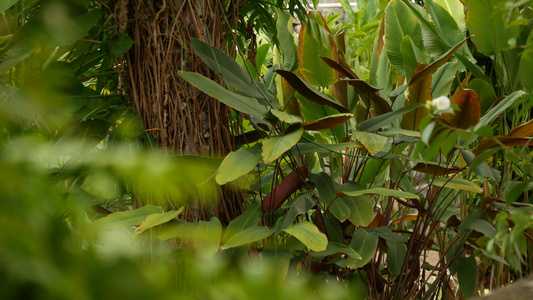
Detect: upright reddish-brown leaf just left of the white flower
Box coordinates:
(401, 63, 431, 131)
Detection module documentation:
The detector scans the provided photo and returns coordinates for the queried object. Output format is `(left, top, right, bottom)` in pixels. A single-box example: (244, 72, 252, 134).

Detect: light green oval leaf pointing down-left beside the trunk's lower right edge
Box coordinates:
(216, 144, 262, 185)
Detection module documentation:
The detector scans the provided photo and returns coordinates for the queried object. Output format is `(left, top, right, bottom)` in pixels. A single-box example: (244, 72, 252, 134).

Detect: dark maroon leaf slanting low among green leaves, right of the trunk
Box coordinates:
(263, 166, 308, 212)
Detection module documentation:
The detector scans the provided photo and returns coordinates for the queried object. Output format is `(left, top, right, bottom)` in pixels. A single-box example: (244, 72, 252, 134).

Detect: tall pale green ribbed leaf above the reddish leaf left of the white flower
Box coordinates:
(385, 0, 424, 75)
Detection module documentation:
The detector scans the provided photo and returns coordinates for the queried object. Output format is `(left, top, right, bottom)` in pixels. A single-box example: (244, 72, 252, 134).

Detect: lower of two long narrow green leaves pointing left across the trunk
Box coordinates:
(179, 71, 269, 117)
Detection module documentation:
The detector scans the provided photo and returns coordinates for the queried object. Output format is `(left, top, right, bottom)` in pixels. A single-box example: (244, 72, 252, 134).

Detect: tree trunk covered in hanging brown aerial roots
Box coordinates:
(114, 0, 244, 223)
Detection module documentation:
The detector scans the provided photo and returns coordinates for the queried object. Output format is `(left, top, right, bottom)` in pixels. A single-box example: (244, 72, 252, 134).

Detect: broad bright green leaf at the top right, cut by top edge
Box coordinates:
(466, 0, 521, 53)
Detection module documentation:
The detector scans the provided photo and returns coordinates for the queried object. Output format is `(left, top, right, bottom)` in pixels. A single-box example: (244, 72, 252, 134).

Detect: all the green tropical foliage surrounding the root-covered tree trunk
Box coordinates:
(0, 0, 533, 299)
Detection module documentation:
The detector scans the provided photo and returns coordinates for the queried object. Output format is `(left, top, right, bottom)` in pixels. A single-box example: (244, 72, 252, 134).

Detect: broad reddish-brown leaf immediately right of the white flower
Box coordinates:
(442, 90, 481, 129)
